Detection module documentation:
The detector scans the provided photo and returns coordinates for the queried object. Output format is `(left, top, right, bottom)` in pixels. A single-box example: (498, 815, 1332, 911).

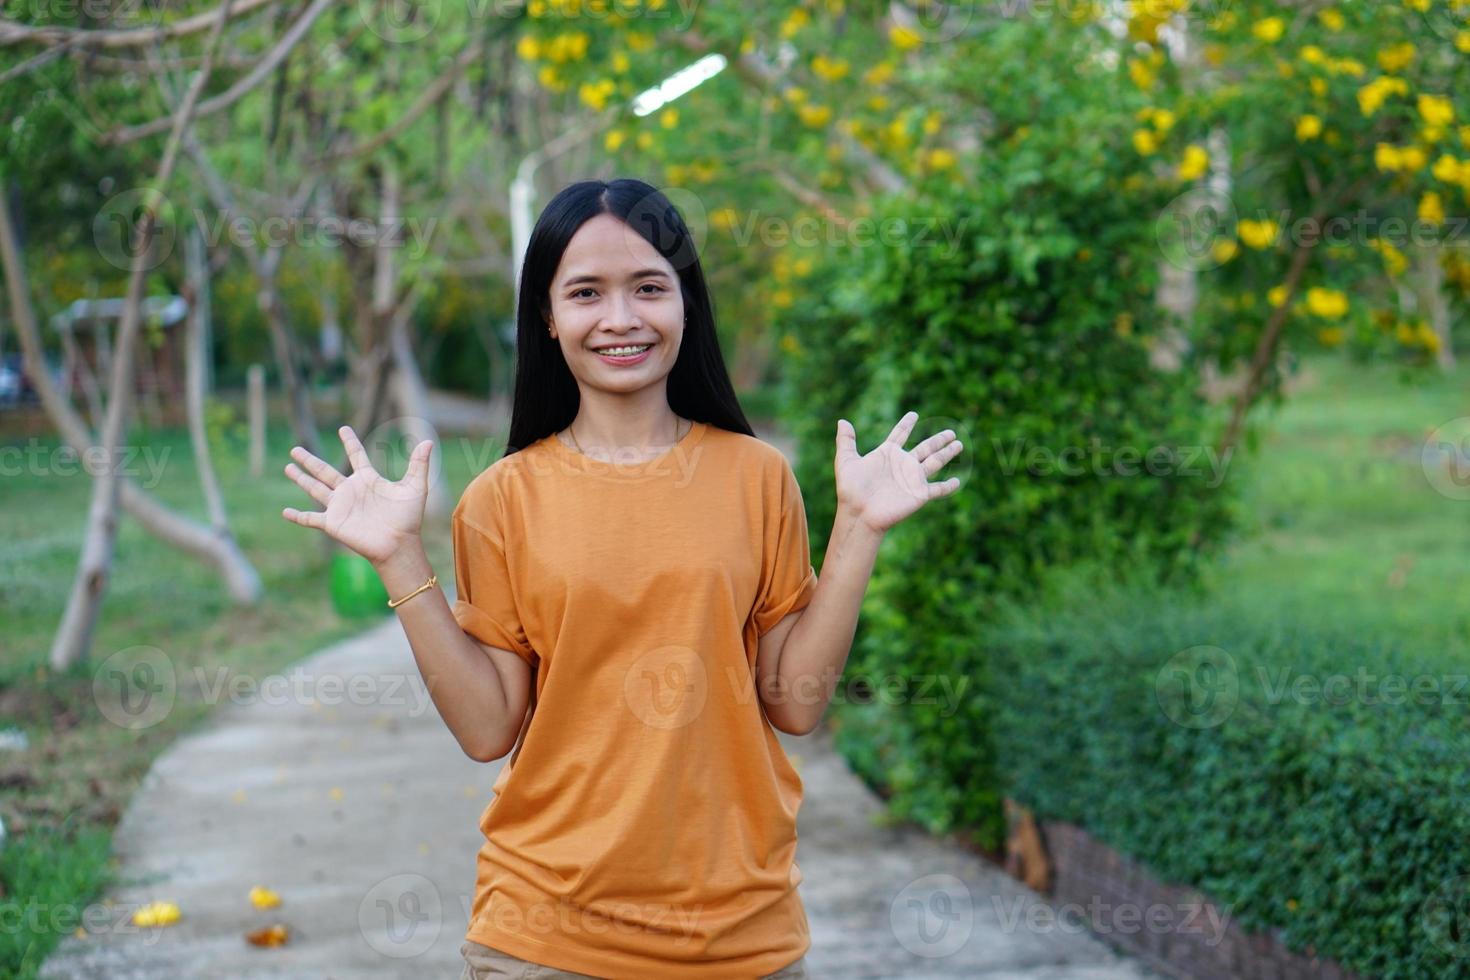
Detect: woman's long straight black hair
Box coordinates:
(504, 178, 756, 455)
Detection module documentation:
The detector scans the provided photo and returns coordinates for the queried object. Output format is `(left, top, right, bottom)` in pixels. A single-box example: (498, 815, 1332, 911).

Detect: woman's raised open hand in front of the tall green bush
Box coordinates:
(833, 411, 963, 532)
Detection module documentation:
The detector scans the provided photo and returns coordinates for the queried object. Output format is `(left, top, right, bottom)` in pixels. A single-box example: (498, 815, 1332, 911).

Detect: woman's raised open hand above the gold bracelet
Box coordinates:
(281, 426, 434, 564)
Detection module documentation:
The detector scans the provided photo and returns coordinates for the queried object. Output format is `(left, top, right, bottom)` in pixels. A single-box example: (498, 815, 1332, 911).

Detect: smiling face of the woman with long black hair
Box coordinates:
(550, 215, 684, 392)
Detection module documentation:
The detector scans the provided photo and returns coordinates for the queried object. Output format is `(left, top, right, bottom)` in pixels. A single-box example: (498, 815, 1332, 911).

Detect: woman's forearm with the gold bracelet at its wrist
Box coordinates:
(373, 539, 522, 760)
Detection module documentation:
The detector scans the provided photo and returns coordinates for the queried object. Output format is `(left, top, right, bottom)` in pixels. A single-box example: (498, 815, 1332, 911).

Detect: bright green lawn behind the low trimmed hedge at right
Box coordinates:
(1211, 357, 1470, 658)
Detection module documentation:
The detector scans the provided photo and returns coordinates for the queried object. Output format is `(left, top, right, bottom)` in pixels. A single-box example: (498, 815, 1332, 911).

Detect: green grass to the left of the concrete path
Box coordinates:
(0, 402, 501, 977)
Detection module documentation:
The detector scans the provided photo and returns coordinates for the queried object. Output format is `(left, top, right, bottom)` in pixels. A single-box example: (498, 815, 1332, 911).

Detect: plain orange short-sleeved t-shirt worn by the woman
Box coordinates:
(453, 422, 817, 980)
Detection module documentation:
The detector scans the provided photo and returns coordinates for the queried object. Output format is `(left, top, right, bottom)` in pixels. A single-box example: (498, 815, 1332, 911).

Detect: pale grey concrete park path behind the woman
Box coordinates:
(41, 411, 1155, 980)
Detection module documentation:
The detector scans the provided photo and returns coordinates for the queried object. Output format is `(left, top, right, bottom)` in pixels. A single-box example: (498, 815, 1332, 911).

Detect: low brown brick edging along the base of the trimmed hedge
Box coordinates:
(1038, 820, 1363, 980)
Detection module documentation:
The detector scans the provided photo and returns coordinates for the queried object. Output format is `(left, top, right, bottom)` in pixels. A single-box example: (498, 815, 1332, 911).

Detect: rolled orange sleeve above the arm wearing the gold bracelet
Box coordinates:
(450, 490, 535, 666)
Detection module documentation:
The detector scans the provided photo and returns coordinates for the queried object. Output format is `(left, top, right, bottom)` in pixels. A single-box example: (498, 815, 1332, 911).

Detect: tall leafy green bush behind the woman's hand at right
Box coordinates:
(785, 145, 1232, 848)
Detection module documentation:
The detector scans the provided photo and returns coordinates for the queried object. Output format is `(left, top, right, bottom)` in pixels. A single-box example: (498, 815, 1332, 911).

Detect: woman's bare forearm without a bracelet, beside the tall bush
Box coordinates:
(776, 507, 883, 732)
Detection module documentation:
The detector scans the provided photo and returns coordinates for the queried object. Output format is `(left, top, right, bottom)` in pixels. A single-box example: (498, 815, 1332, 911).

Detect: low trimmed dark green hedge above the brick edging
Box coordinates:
(981, 582, 1470, 980)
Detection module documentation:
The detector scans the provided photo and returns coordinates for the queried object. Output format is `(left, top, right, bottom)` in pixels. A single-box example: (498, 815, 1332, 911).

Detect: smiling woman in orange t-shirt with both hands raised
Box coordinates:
(284, 179, 961, 980)
